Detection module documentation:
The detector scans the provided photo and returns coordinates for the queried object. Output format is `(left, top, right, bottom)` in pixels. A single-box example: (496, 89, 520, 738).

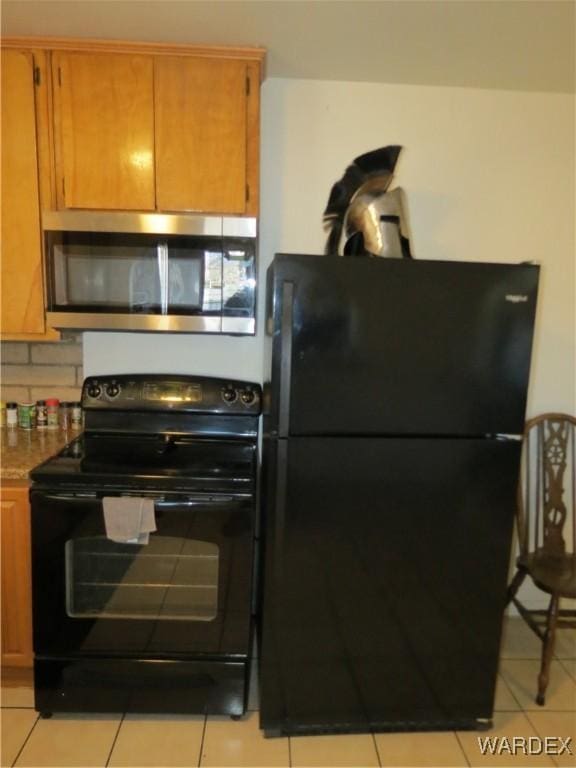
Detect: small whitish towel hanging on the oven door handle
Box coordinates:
(102, 496, 156, 544)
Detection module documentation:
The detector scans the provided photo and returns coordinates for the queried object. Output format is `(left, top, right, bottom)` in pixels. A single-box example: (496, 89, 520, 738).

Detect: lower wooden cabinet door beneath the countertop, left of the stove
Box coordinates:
(0, 487, 32, 667)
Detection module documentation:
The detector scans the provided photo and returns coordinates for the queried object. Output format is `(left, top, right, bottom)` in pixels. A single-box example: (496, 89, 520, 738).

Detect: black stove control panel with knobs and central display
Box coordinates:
(82, 374, 262, 415)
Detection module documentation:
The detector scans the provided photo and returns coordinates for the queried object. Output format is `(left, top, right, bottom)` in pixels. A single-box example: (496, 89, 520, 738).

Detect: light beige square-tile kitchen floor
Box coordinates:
(1, 619, 576, 768)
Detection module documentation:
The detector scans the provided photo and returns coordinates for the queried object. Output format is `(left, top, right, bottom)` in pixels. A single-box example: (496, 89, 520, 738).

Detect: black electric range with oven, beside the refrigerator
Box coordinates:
(30, 374, 261, 716)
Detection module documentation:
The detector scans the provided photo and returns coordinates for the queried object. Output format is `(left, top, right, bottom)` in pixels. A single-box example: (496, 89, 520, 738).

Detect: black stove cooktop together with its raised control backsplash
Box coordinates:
(30, 374, 262, 493)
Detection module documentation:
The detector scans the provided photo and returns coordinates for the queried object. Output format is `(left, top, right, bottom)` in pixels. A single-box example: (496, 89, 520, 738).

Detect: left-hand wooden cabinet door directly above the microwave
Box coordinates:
(52, 52, 155, 210)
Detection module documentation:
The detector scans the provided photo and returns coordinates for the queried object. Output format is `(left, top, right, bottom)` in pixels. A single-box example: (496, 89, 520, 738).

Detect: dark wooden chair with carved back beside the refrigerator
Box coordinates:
(507, 413, 576, 705)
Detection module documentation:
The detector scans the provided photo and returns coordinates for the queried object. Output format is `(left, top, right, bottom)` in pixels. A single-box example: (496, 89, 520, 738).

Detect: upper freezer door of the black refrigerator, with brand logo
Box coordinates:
(269, 255, 539, 436)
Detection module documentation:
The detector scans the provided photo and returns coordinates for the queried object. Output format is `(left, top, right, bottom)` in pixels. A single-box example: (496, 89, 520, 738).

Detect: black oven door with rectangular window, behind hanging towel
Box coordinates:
(30, 489, 254, 658)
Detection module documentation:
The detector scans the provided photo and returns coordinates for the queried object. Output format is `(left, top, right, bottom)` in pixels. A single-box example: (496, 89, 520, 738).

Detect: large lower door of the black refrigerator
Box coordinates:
(260, 438, 520, 734)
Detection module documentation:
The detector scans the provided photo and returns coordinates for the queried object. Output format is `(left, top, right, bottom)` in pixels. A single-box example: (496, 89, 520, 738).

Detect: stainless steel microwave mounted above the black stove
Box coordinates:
(42, 211, 257, 334)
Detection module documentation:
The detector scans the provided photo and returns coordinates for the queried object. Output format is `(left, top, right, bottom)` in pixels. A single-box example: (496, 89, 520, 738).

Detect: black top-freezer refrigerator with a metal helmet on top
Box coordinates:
(259, 254, 539, 735)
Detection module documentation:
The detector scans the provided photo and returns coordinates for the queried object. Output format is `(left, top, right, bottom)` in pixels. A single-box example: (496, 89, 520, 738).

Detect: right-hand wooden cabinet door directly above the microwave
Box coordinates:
(154, 56, 249, 213)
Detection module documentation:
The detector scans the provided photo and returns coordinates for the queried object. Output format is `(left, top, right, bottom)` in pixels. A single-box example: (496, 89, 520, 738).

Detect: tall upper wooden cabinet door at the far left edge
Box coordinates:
(2, 50, 45, 334)
